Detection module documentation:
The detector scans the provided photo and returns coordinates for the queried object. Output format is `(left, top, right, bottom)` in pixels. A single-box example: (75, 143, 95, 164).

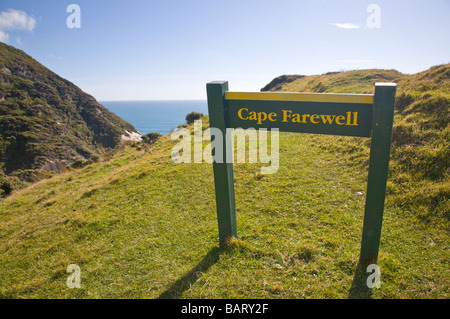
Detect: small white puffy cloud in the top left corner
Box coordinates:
(0, 9, 36, 42)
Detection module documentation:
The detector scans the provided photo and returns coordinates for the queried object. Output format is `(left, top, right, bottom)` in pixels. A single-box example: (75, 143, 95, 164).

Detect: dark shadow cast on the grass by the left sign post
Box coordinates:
(157, 247, 220, 299)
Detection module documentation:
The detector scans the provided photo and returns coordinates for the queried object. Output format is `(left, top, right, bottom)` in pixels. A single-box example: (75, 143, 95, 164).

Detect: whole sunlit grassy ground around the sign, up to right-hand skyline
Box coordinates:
(0, 65, 450, 298)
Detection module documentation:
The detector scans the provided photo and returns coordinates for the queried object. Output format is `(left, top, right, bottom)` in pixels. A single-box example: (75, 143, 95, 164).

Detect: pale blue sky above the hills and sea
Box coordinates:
(0, 0, 450, 101)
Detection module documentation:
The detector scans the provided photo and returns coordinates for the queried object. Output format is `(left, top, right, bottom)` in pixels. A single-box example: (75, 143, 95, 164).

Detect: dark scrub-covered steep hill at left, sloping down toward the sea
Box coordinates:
(0, 43, 141, 174)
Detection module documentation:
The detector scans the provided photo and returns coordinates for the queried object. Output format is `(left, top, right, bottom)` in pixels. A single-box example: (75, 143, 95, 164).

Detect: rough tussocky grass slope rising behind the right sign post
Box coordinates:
(266, 64, 450, 227)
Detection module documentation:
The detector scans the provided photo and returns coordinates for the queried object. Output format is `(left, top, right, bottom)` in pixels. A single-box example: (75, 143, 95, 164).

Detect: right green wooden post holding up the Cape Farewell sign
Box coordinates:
(360, 83, 396, 264)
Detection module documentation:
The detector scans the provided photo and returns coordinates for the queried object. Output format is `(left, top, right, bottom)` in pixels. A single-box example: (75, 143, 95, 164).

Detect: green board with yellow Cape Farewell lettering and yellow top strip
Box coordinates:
(225, 92, 373, 137)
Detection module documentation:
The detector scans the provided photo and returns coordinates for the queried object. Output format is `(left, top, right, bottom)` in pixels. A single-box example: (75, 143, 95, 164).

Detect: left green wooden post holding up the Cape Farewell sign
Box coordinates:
(206, 81, 237, 246)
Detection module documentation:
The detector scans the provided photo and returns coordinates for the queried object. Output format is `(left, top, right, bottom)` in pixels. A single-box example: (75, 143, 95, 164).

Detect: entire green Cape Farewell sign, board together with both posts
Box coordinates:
(206, 81, 396, 263)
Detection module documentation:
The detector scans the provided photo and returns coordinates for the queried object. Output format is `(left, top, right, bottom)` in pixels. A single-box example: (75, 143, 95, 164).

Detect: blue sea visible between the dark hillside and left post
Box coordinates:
(99, 100, 208, 135)
